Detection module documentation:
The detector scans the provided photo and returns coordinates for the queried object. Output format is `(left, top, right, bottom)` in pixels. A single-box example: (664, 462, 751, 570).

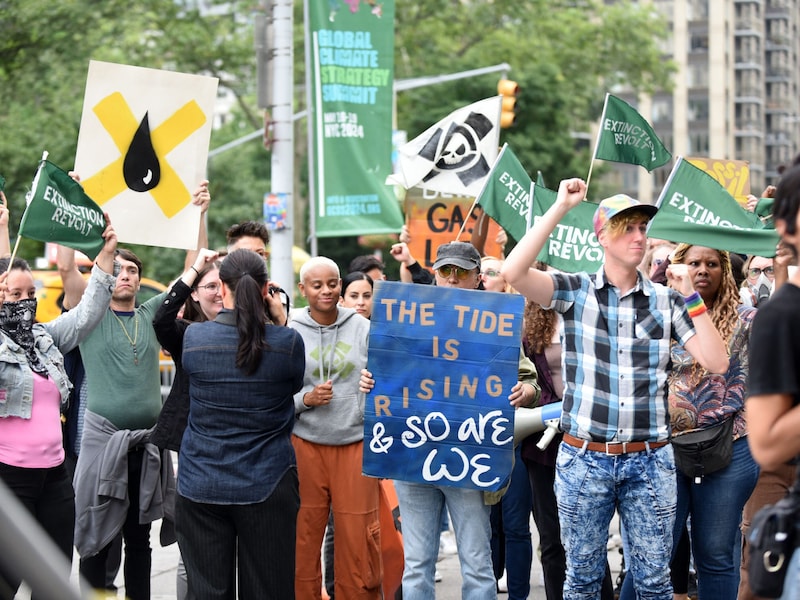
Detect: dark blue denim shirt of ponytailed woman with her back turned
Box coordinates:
(178, 310, 305, 504)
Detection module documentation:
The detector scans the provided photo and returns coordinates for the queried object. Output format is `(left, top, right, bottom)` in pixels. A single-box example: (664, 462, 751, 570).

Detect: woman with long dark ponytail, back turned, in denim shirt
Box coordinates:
(176, 250, 305, 600)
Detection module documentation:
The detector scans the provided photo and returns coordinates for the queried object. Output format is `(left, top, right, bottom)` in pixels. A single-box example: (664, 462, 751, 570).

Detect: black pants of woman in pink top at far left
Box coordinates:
(0, 463, 75, 600)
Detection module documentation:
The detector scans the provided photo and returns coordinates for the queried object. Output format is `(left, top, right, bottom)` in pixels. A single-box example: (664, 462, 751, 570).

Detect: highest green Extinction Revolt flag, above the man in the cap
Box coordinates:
(594, 94, 672, 171)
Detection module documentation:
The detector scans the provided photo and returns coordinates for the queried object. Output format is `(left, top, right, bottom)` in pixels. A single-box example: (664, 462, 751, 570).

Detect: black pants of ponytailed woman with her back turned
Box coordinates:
(175, 468, 300, 600)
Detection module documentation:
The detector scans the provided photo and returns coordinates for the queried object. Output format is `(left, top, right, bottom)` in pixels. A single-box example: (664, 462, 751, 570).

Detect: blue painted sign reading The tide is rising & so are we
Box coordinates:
(363, 281, 524, 491)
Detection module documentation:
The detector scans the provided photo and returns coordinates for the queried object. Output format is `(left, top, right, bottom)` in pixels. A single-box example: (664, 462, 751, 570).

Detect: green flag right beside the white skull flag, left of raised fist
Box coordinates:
(476, 144, 531, 241)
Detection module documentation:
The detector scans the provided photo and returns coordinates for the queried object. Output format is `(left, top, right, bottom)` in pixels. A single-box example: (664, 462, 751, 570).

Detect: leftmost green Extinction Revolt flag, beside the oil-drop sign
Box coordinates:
(19, 160, 106, 260)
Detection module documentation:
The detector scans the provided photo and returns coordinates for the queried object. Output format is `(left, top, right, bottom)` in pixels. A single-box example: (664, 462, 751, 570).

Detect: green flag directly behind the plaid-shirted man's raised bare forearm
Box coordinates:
(531, 185, 603, 273)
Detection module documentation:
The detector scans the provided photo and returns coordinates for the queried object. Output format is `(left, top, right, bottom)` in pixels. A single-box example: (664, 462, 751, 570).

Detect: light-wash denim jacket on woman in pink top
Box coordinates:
(0, 265, 116, 419)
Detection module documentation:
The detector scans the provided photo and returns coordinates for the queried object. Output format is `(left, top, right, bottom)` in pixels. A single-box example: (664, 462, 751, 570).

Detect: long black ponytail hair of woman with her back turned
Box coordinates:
(219, 249, 268, 375)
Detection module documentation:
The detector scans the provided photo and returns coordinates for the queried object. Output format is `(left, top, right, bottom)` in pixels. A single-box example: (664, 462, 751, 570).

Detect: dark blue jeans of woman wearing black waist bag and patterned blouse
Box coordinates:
(620, 437, 758, 600)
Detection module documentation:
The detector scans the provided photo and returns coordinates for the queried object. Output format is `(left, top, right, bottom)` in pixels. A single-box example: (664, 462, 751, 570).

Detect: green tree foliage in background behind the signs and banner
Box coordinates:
(0, 0, 673, 281)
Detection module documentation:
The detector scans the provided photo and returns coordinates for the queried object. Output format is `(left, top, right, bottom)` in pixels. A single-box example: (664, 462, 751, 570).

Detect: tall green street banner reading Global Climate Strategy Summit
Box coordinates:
(306, 0, 403, 237)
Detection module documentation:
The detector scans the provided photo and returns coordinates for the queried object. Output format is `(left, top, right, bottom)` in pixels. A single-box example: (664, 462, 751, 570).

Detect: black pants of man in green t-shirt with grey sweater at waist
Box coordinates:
(80, 448, 152, 600)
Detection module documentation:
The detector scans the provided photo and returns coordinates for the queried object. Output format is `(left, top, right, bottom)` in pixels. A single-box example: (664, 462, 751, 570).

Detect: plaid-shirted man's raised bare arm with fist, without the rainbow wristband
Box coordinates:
(500, 179, 586, 306)
